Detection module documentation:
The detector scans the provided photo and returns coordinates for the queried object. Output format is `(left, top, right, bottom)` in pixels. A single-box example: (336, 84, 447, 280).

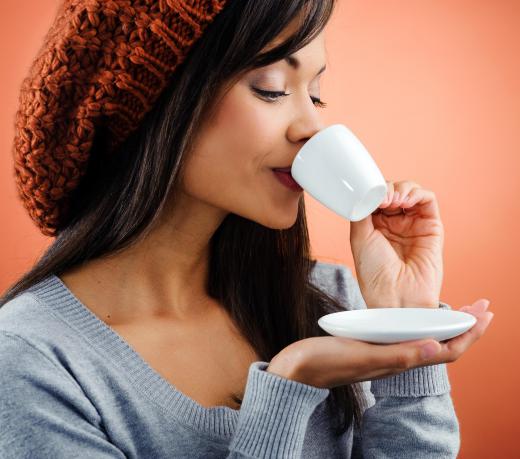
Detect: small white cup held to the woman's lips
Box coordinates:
(291, 124, 387, 222)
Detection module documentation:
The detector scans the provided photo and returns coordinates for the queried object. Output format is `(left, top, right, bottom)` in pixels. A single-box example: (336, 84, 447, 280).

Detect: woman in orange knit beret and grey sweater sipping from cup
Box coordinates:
(0, 0, 490, 458)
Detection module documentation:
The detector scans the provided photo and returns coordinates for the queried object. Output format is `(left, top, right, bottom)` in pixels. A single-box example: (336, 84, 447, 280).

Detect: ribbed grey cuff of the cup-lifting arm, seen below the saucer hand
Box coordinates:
(370, 301, 451, 397)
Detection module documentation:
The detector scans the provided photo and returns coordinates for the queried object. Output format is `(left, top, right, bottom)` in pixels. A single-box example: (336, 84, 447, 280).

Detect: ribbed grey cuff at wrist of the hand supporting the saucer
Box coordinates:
(229, 362, 330, 458)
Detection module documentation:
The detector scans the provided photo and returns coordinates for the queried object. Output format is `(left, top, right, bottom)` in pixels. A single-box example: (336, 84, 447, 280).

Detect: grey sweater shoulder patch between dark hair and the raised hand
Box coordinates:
(311, 260, 366, 310)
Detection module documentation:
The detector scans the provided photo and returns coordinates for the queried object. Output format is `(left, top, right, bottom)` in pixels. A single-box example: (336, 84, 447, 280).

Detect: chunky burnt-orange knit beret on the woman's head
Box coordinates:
(13, 0, 227, 236)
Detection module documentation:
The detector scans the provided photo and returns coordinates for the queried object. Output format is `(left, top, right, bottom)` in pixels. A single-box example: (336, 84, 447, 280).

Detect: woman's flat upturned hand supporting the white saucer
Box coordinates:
(266, 299, 493, 389)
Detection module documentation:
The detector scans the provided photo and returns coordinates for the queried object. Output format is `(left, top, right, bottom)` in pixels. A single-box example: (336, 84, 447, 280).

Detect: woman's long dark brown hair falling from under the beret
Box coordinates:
(0, 0, 364, 435)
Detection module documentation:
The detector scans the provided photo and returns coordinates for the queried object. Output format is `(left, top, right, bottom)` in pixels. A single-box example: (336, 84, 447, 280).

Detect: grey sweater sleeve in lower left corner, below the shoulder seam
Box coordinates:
(0, 332, 125, 459)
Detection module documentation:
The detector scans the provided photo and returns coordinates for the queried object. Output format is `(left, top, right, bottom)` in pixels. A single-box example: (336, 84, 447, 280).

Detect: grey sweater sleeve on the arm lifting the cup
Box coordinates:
(340, 267, 460, 459)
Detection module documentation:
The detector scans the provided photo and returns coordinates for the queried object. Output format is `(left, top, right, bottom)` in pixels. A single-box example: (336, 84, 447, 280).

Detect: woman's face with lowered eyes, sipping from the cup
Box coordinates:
(182, 32, 326, 229)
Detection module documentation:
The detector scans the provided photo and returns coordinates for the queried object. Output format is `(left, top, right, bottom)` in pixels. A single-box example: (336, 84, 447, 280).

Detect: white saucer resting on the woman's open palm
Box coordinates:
(318, 308, 477, 344)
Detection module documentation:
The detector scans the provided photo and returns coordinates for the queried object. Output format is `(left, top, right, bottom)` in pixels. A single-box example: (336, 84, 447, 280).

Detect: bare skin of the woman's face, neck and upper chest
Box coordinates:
(60, 17, 326, 409)
